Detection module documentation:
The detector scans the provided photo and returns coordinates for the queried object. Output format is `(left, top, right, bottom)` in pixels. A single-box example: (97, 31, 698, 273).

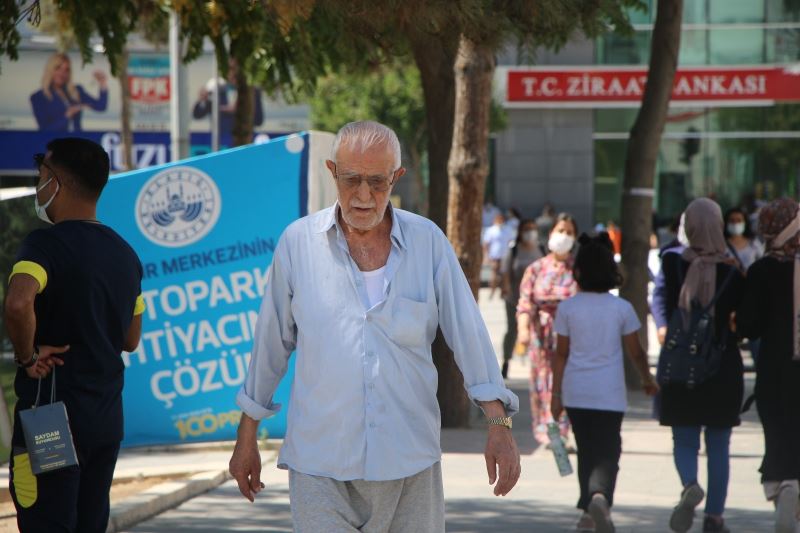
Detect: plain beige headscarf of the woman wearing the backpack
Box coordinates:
(678, 198, 727, 318)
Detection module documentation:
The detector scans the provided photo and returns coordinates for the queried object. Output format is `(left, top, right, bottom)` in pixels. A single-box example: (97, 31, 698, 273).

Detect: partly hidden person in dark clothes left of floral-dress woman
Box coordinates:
(500, 220, 544, 378)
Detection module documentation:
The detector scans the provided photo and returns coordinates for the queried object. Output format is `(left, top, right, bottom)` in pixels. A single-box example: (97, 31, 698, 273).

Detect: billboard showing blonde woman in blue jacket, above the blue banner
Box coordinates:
(0, 48, 309, 175)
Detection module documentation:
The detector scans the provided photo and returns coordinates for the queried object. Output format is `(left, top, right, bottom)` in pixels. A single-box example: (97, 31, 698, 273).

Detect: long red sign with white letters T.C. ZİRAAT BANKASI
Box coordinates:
(506, 66, 800, 107)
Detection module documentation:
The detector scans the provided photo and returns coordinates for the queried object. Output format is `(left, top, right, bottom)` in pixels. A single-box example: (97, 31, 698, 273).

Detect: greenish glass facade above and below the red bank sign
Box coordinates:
(594, 0, 800, 224)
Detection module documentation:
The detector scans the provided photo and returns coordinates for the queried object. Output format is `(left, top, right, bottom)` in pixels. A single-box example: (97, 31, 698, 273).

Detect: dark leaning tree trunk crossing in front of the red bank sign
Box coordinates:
(621, 0, 683, 388)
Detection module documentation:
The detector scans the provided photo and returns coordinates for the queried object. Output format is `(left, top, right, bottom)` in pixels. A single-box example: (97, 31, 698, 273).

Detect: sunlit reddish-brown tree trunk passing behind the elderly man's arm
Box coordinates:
(432, 36, 494, 427)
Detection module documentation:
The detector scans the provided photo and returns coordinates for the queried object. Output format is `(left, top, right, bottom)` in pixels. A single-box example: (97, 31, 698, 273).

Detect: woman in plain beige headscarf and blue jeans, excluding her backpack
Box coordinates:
(659, 198, 744, 532)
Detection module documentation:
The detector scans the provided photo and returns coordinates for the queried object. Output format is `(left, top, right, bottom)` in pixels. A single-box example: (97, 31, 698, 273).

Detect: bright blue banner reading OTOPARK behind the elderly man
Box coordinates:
(98, 133, 311, 446)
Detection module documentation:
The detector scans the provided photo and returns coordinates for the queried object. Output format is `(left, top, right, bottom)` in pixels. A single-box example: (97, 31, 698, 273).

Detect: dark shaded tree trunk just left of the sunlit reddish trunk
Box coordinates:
(408, 30, 458, 232)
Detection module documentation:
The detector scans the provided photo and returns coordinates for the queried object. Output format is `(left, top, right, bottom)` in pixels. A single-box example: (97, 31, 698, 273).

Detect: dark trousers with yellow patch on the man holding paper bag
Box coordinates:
(9, 442, 119, 533)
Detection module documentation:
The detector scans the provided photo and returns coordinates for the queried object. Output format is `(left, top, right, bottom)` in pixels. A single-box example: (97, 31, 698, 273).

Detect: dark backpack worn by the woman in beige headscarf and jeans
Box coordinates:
(656, 264, 736, 389)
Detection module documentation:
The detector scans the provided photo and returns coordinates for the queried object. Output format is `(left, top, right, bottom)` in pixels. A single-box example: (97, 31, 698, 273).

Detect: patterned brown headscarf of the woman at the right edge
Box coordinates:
(758, 198, 800, 361)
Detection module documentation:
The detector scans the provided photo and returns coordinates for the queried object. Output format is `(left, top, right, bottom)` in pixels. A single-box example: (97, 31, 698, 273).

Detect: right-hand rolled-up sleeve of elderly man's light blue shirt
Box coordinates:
(434, 240, 519, 416)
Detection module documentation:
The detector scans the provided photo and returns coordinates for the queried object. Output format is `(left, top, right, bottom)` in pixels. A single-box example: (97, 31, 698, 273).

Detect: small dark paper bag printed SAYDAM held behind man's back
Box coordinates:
(19, 368, 78, 475)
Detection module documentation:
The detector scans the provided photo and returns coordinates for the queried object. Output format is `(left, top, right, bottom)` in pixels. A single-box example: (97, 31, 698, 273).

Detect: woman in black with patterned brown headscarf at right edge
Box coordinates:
(736, 198, 800, 533)
